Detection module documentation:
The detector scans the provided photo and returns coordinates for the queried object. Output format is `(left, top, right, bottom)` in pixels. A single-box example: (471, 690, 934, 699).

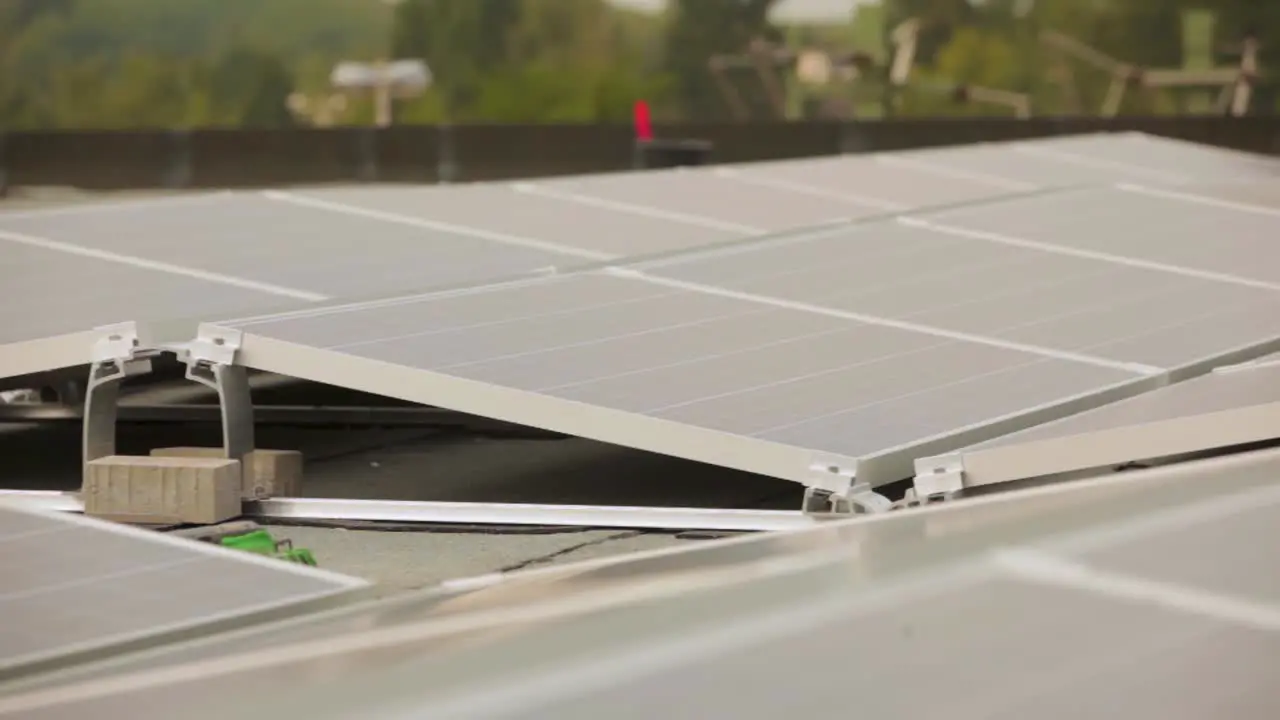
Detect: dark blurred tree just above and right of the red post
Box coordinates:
(663, 0, 781, 119)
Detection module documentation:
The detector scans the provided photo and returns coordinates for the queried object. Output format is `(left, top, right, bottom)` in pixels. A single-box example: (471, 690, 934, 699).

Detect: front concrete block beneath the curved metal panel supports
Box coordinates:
(81, 455, 241, 525)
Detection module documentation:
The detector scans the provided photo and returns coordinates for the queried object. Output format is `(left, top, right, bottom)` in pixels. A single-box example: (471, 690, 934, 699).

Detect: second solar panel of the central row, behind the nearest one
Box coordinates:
(632, 208, 1280, 370)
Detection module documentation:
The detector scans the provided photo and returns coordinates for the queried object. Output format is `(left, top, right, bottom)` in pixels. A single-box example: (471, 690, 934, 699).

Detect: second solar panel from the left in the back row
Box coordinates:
(0, 188, 572, 302)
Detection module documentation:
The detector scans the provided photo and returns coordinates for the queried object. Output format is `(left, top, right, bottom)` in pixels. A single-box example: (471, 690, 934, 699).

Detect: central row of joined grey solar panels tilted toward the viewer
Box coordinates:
(209, 172, 1280, 487)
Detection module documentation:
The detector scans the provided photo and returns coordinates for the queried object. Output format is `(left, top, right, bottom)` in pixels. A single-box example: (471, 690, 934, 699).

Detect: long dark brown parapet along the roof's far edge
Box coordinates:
(0, 115, 1280, 190)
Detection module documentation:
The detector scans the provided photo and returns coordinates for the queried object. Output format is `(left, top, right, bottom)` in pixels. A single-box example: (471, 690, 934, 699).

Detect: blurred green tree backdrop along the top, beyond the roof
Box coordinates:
(0, 0, 1280, 129)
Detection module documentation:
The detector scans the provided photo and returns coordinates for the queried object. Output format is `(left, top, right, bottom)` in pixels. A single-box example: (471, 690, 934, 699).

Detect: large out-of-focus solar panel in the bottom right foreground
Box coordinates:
(220, 445, 1280, 720)
